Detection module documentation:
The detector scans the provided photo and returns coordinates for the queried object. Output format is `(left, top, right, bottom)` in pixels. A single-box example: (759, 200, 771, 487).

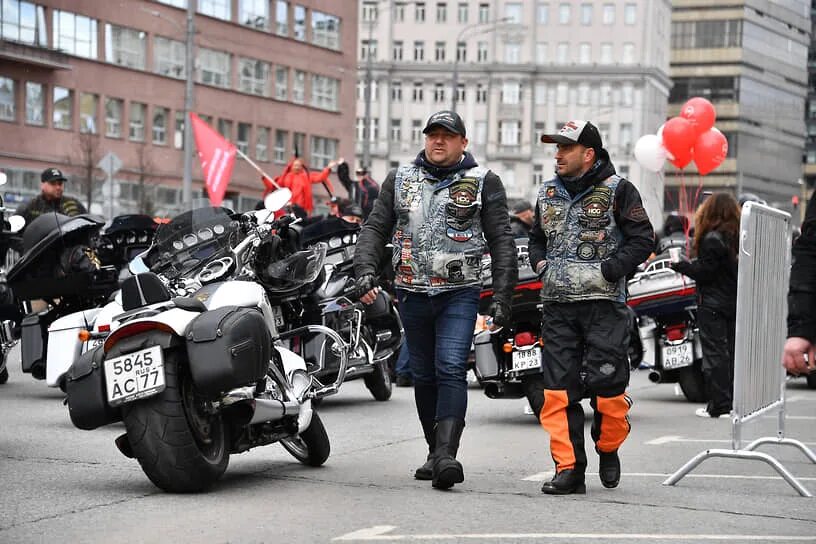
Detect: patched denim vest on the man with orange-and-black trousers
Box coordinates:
(538, 176, 626, 302)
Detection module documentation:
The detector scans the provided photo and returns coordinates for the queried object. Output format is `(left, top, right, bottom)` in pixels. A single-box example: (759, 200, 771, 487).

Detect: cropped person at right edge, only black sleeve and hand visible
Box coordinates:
(782, 198, 816, 375)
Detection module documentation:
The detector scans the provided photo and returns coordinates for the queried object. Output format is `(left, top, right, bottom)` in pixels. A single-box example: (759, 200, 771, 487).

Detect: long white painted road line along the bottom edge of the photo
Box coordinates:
(332, 525, 816, 542)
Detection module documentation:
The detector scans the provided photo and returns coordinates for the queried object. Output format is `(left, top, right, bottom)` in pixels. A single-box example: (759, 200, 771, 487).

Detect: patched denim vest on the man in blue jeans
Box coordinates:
(392, 164, 488, 294)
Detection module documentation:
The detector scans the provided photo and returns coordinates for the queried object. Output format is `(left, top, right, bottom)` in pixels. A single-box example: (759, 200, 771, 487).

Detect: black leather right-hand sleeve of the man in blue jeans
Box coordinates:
(482, 171, 518, 306)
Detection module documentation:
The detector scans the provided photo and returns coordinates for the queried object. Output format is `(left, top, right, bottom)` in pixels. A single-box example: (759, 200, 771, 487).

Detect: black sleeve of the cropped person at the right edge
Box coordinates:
(788, 198, 816, 343)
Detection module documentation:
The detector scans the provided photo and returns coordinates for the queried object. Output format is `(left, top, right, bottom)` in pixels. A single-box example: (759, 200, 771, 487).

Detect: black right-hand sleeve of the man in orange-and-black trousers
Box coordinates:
(600, 179, 655, 282)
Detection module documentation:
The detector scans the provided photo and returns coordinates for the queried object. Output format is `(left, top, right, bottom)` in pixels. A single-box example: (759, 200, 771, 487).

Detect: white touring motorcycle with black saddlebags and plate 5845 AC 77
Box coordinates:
(64, 196, 348, 492)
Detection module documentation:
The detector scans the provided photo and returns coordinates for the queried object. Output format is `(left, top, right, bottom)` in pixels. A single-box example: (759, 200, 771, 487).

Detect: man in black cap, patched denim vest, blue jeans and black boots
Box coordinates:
(354, 111, 518, 489)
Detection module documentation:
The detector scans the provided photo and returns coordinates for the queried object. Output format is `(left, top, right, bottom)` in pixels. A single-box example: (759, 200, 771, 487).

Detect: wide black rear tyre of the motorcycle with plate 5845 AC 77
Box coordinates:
(122, 351, 229, 493)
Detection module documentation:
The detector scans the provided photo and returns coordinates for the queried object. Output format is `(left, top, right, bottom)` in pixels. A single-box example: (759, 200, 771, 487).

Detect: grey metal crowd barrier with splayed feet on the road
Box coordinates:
(663, 202, 816, 497)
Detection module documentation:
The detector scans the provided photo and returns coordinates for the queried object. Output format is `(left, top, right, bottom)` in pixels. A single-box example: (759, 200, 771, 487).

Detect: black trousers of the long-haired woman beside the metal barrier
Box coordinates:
(697, 307, 736, 416)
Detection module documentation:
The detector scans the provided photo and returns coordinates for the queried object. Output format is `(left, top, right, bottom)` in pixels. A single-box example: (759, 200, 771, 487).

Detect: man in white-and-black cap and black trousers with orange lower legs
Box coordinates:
(529, 121, 654, 495)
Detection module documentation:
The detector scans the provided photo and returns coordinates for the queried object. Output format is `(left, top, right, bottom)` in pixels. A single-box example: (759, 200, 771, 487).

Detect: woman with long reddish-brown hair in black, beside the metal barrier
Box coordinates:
(671, 193, 740, 417)
